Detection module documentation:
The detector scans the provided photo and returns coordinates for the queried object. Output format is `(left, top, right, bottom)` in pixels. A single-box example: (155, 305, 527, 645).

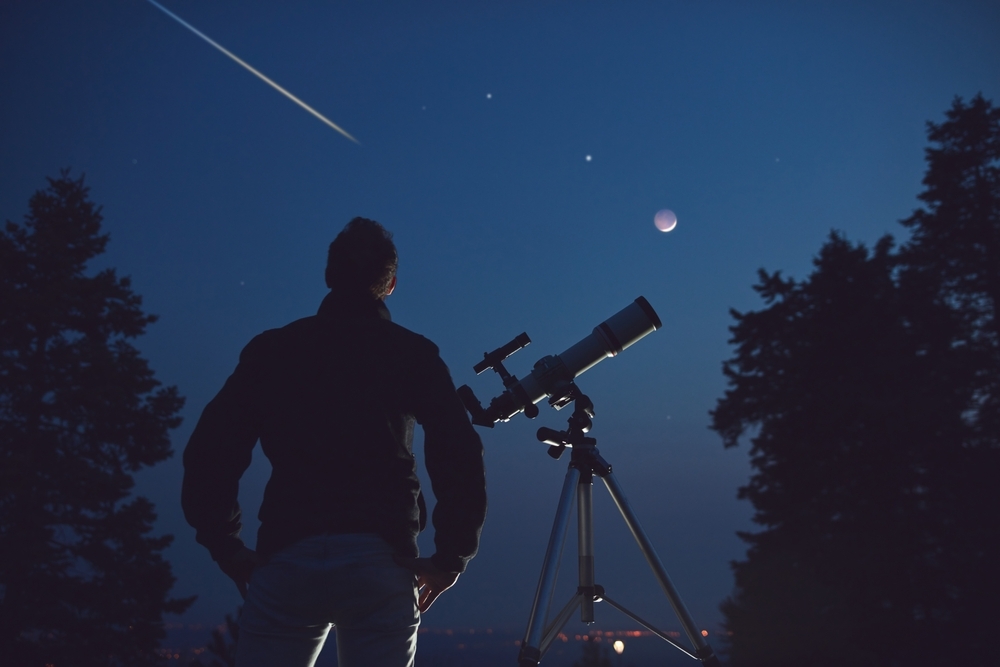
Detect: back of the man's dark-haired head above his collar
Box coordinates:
(326, 218, 399, 299)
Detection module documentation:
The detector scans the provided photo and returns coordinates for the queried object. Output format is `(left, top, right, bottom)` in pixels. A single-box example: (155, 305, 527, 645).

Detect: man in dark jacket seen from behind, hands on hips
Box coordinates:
(182, 218, 486, 667)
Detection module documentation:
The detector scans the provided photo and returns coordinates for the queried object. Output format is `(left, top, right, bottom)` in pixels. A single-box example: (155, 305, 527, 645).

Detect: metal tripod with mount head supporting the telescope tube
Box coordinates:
(518, 392, 721, 667)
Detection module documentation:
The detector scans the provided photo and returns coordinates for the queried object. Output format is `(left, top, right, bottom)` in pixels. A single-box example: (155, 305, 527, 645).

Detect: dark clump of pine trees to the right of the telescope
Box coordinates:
(712, 97, 1000, 666)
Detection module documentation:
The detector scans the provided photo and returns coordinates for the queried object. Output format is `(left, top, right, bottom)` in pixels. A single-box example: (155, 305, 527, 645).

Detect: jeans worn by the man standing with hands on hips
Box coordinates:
(236, 534, 420, 667)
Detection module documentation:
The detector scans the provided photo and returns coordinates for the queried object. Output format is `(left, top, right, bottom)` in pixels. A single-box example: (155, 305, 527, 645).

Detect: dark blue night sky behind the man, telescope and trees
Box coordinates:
(0, 0, 1000, 640)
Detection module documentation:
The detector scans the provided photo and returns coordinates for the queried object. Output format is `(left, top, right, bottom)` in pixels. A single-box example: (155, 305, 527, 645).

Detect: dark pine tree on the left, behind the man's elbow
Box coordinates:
(0, 171, 193, 666)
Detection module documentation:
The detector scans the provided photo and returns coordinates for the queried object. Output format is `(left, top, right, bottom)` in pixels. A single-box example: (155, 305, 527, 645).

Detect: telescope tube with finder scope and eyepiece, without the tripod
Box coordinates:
(458, 296, 663, 428)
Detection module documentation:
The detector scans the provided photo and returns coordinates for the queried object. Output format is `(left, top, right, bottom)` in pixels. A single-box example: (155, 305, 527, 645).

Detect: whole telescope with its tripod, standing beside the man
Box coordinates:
(458, 296, 721, 667)
